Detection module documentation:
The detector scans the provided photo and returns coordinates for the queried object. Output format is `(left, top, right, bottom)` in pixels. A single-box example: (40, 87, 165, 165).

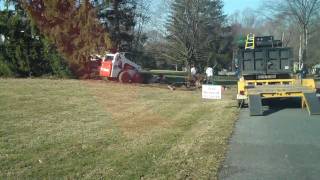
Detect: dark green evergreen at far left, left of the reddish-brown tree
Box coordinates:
(0, 1, 69, 77)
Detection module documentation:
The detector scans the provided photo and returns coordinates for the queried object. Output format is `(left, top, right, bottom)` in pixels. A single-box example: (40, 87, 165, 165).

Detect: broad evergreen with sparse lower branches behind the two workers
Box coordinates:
(165, 0, 230, 71)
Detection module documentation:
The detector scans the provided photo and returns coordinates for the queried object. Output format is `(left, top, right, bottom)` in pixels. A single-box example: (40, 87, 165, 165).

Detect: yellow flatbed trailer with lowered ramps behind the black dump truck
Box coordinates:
(237, 78, 320, 115)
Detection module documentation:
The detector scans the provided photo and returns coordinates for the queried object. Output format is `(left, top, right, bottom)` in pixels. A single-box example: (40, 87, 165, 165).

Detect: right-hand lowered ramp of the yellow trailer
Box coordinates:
(303, 93, 320, 115)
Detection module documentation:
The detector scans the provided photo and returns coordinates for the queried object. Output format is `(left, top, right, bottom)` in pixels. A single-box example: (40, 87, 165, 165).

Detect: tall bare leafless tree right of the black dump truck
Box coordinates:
(264, 0, 320, 63)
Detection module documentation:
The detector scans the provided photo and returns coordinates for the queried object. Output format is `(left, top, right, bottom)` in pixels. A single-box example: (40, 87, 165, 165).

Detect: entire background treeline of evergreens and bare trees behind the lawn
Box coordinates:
(0, 0, 320, 77)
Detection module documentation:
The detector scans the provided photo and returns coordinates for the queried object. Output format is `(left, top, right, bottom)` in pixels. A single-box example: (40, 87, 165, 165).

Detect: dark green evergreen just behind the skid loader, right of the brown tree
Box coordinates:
(93, 0, 154, 67)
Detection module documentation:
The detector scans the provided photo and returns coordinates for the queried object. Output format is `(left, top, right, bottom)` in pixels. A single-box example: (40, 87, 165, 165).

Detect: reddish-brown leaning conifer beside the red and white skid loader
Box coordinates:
(23, 0, 111, 77)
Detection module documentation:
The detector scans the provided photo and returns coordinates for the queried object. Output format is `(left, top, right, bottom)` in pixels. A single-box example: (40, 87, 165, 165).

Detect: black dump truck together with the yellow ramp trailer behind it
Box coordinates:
(235, 34, 320, 115)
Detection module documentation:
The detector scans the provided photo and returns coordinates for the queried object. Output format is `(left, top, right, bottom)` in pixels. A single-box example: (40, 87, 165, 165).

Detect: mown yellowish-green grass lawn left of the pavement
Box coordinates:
(0, 79, 238, 179)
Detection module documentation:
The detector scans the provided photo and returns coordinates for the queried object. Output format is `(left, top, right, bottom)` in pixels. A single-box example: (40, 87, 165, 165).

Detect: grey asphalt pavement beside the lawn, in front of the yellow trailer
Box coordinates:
(219, 102, 320, 180)
